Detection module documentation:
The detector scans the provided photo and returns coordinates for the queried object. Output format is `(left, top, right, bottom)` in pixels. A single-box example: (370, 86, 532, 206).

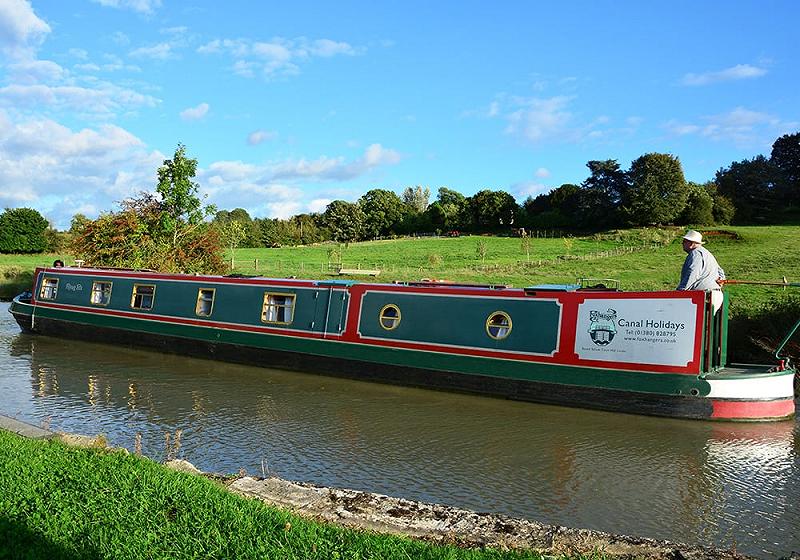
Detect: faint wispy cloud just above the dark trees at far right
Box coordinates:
(664, 107, 799, 147)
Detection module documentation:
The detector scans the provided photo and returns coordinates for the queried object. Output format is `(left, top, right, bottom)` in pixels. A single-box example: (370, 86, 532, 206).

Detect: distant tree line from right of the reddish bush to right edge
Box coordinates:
(206, 133, 800, 247)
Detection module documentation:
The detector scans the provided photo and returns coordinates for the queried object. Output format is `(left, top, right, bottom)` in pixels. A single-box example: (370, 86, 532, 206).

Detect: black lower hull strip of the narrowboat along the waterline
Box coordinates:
(28, 313, 712, 419)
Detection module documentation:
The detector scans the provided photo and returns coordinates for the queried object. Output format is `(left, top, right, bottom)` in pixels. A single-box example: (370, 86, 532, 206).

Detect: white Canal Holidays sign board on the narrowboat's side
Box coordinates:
(575, 298, 697, 367)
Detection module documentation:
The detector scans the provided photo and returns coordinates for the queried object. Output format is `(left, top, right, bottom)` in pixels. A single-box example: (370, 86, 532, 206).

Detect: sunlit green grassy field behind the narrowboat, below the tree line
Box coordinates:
(0, 226, 800, 360)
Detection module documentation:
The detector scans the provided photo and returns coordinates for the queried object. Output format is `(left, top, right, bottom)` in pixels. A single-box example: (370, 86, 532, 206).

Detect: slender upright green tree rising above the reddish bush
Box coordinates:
(156, 144, 216, 247)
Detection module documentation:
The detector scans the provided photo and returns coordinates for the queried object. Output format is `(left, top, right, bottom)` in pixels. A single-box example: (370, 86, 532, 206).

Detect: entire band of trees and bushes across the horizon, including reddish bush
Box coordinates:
(0, 133, 800, 272)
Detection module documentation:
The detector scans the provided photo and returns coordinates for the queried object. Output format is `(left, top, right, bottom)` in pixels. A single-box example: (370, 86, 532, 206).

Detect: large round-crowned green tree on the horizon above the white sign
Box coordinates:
(622, 153, 687, 226)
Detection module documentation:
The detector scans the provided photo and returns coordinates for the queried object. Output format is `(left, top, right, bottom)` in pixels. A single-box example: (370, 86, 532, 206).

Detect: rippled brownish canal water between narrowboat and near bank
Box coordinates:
(0, 303, 800, 558)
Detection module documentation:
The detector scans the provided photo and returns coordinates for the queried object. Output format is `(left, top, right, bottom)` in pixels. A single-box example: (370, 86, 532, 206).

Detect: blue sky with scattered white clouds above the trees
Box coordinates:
(0, 0, 800, 229)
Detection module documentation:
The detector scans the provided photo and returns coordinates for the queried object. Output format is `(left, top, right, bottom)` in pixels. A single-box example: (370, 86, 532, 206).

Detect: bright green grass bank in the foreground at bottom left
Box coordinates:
(0, 430, 552, 560)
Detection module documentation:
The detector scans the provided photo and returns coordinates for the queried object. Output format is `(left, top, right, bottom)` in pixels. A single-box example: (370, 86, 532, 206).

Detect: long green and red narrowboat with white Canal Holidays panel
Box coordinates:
(10, 267, 795, 421)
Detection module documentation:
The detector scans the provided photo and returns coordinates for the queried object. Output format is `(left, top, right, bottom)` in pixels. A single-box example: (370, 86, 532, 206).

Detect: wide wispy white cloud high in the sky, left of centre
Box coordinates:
(197, 37, 363, 79)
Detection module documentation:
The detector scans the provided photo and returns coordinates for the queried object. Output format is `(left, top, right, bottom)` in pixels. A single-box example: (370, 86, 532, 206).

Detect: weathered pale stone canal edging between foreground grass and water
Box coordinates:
(0, 415, 760, 560)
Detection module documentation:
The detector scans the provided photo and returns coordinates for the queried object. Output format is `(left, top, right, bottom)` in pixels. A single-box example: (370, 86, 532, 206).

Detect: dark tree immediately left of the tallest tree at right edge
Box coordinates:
(714, 156, 781, 223)
